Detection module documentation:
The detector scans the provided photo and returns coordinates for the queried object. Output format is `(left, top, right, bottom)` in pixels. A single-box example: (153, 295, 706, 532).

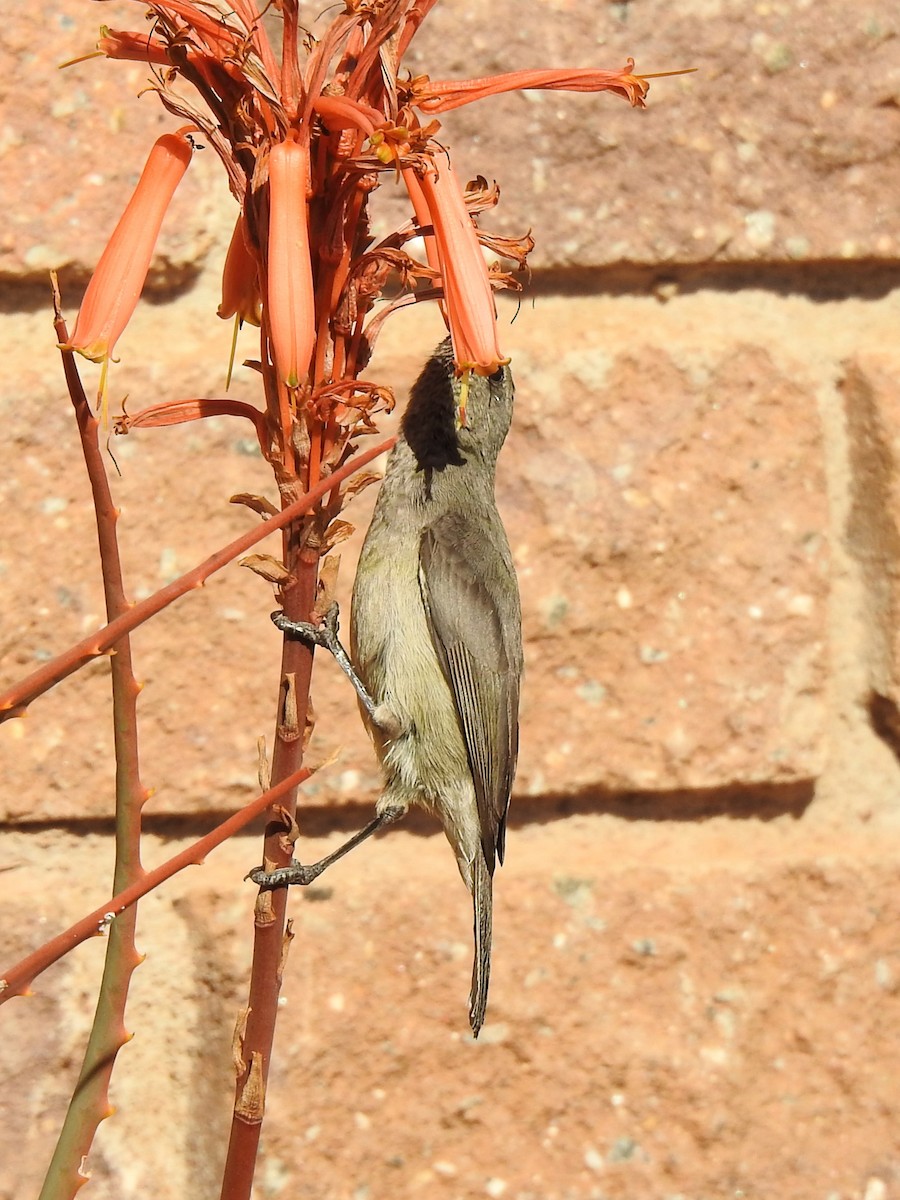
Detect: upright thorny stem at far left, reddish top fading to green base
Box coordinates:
(41, 288, 148, 1200)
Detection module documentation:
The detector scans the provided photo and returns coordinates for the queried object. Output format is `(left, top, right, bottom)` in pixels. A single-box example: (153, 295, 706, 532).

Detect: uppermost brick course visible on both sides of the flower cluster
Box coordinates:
(0, 0, 900, 288)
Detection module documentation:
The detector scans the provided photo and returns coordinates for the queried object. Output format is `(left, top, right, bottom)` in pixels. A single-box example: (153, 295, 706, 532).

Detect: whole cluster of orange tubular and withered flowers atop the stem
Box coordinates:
(68, 0, 672, 482)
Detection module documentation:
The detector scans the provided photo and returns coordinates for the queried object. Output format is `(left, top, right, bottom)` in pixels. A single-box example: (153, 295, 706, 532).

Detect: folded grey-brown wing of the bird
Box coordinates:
(419, 514, 522, 872)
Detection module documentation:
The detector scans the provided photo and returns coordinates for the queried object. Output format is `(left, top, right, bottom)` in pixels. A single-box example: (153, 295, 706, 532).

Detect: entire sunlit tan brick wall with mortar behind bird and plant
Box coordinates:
(0, 0, 900, 1200)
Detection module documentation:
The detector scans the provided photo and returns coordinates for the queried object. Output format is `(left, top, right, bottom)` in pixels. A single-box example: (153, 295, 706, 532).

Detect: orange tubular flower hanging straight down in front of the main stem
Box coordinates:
(268, 142, 316, 388)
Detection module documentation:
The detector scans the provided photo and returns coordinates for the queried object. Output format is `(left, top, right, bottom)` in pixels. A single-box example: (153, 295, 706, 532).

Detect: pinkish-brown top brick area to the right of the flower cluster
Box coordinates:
(393, 0, 900, 265)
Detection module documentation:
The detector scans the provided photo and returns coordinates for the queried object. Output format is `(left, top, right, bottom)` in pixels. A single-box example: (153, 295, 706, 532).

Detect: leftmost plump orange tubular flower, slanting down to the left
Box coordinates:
(61, 132, 193, 362)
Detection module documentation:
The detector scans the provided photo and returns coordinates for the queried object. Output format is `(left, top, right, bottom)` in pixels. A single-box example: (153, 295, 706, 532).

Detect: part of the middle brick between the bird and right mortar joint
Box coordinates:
(504, 333, 828, 793)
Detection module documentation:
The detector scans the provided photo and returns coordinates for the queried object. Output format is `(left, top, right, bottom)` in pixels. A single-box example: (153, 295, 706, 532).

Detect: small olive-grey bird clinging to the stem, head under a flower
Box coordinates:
(251, 338, 522, 1037)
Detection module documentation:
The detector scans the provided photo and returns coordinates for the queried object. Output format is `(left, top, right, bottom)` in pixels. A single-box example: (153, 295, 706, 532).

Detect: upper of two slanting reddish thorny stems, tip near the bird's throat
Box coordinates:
(0, 438, 396, 721)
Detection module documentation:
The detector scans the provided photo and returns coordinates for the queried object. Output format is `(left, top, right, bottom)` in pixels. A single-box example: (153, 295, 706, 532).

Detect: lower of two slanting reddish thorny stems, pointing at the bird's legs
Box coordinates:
(0, 767, 314, 1004)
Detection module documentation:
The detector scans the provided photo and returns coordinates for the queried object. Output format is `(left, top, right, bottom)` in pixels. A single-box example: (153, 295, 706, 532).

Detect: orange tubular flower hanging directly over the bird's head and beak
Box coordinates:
(414, 154, 509, 374)
